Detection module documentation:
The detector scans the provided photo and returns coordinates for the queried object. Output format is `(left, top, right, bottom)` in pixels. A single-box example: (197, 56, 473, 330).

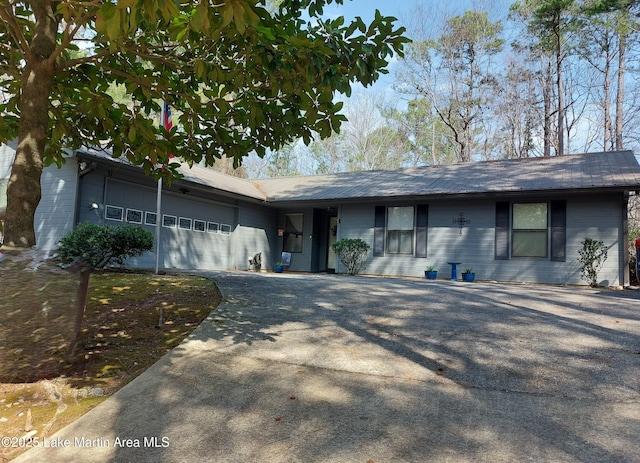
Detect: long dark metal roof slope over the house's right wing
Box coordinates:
(254, 151, 640, 202)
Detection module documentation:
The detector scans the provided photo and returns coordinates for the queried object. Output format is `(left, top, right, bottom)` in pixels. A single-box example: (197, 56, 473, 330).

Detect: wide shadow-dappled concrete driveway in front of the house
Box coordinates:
(14, 272, 640, 463)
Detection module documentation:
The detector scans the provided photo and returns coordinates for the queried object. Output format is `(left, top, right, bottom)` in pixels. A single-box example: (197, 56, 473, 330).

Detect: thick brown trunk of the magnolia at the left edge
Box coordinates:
(4, 0, 58, 248)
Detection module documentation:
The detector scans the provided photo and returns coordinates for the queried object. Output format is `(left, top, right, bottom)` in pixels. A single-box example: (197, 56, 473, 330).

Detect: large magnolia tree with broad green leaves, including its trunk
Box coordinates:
(0, 0, 407, 247)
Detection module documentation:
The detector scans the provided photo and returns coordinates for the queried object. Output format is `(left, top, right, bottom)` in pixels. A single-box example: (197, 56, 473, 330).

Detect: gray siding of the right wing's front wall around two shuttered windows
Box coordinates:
(337, 195, 624, 285)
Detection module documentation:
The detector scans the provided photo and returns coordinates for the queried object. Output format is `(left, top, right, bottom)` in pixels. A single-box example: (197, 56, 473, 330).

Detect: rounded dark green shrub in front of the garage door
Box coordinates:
(58, 223, 153, 270)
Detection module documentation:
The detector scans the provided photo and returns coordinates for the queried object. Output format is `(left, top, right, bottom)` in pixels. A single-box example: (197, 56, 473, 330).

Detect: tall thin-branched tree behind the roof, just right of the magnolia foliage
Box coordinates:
(399, 7, 503, 161)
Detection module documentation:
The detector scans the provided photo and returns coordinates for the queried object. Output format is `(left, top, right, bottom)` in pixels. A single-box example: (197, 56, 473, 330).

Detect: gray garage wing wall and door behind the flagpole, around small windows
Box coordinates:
(78, 169, 277, 270)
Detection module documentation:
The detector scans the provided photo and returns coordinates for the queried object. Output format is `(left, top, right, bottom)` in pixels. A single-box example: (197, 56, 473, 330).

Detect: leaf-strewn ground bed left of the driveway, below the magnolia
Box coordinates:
(0, 259, 220, 462)
